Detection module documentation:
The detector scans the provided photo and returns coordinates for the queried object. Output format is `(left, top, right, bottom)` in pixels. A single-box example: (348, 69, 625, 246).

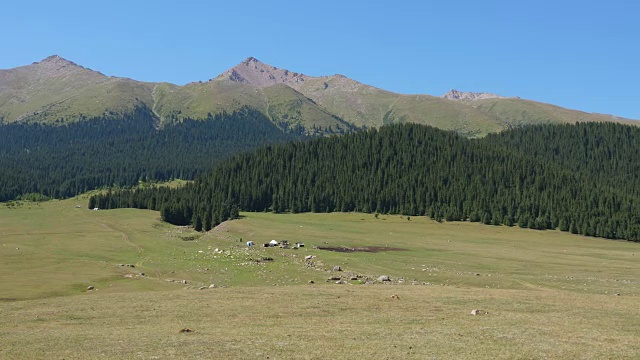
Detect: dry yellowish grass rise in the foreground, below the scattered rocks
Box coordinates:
(0, 285, 640, 359)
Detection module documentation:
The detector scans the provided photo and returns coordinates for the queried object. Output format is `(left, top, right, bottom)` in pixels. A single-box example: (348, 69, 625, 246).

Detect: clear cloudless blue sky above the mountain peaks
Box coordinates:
(0, 0, 640, 119)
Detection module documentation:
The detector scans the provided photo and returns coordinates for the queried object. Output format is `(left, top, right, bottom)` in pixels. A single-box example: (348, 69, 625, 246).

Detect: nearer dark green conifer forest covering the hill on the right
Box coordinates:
(89, 123, 640, 241)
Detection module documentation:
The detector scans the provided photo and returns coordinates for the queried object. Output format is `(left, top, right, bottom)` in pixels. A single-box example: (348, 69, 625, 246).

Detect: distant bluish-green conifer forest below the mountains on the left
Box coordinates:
(0, 107, 305, 201)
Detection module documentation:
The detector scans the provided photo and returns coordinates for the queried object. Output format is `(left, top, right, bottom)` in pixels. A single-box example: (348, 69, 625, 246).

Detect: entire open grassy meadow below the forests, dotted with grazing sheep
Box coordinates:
(0, 196, 640, 359)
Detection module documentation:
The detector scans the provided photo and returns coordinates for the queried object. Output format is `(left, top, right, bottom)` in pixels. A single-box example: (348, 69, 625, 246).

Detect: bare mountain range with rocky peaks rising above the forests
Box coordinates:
(0, 55, 637, 137)
